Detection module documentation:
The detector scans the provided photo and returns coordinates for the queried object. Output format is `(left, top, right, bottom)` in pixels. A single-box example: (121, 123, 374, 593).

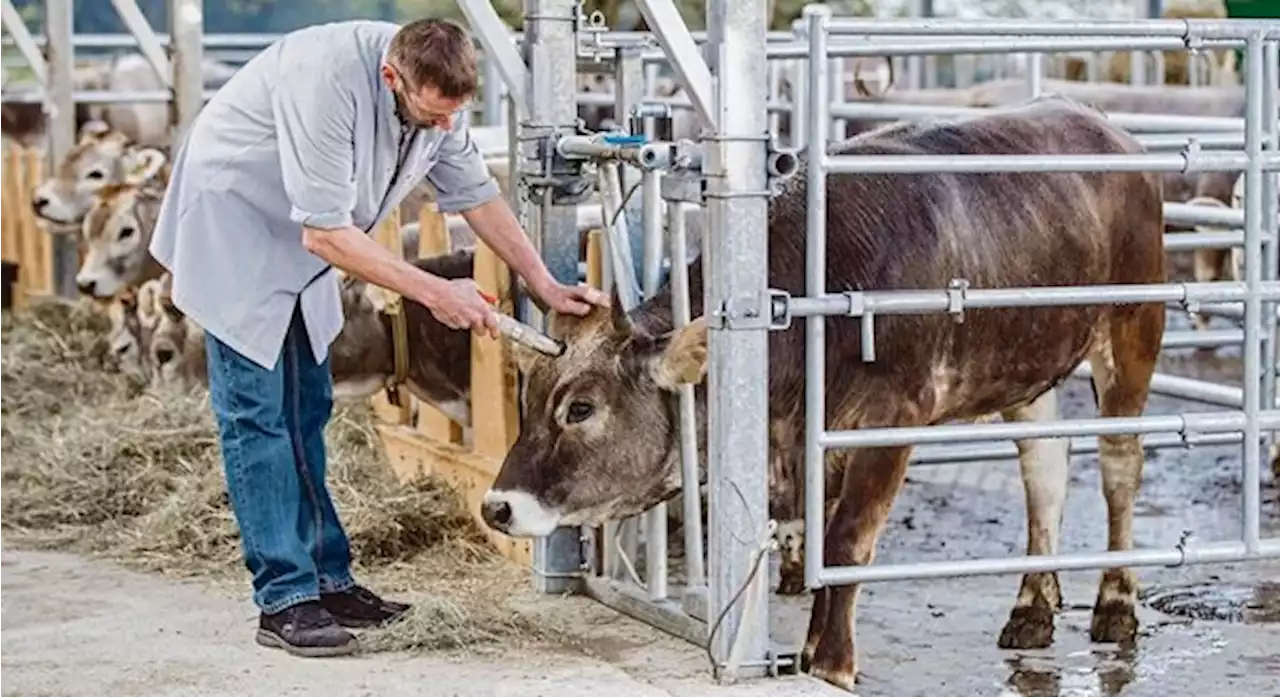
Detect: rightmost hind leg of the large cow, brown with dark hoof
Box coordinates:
(1089, 306, 1165, 643)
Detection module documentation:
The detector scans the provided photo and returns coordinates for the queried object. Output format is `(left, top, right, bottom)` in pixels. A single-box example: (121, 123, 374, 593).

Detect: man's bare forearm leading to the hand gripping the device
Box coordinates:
(302, 226, 444, 306)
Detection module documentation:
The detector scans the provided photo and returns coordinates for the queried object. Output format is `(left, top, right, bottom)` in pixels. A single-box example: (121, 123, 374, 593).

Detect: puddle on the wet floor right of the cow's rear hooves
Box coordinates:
(1139, 582, 1280, 624)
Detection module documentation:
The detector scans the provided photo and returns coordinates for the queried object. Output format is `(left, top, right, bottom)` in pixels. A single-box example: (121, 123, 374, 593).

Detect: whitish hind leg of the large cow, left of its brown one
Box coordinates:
(998, 389, 1070, 648)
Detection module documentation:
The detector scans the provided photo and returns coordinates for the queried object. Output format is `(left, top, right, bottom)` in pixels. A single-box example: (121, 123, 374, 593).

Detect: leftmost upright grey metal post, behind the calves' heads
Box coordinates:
(45, 0, 79, 298)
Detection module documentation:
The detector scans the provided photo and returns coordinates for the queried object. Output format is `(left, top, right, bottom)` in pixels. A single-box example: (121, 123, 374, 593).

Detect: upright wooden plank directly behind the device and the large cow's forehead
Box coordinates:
(471, 242, 520, 462)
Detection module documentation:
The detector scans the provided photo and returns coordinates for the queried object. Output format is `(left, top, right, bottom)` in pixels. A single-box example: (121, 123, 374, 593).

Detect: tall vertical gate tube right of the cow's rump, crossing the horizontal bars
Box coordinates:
(1240, 31, 1265, 554)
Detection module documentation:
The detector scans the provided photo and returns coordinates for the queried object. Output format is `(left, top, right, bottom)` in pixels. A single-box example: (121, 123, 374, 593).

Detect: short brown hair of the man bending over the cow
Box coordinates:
(387, 19, 479, 100)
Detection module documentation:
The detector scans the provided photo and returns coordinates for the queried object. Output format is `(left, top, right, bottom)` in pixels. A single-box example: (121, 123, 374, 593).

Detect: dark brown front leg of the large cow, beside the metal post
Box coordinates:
(801, 448, 911, 692)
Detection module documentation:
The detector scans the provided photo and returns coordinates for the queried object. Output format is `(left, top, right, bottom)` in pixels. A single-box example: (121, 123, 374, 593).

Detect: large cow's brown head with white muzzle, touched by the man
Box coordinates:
(483, 297, 707, 537)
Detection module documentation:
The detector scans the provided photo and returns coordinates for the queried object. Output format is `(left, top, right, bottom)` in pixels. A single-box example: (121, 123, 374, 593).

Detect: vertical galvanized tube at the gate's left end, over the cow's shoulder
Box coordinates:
(804, 5, 831, 588)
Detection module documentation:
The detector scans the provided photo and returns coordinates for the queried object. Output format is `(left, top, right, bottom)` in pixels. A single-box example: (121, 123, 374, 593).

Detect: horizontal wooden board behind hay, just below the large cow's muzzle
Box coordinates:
(378, 425, 534, 565)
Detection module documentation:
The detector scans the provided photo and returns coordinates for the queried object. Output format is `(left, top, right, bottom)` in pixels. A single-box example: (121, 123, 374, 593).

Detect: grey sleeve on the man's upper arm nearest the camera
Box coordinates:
(271, 58, 356, 229)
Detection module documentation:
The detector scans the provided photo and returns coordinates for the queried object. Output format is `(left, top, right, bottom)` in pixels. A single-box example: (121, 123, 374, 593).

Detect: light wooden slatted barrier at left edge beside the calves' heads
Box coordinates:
(0, 139, 54, 307)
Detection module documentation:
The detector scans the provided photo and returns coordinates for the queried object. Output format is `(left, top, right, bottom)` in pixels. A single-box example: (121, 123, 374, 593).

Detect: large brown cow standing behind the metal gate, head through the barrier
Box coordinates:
(483, 97, 1165, 689)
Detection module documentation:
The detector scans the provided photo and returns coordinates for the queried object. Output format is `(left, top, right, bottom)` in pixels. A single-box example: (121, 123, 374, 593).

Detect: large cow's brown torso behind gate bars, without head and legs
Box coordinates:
(732, 97, 1165, 421)
